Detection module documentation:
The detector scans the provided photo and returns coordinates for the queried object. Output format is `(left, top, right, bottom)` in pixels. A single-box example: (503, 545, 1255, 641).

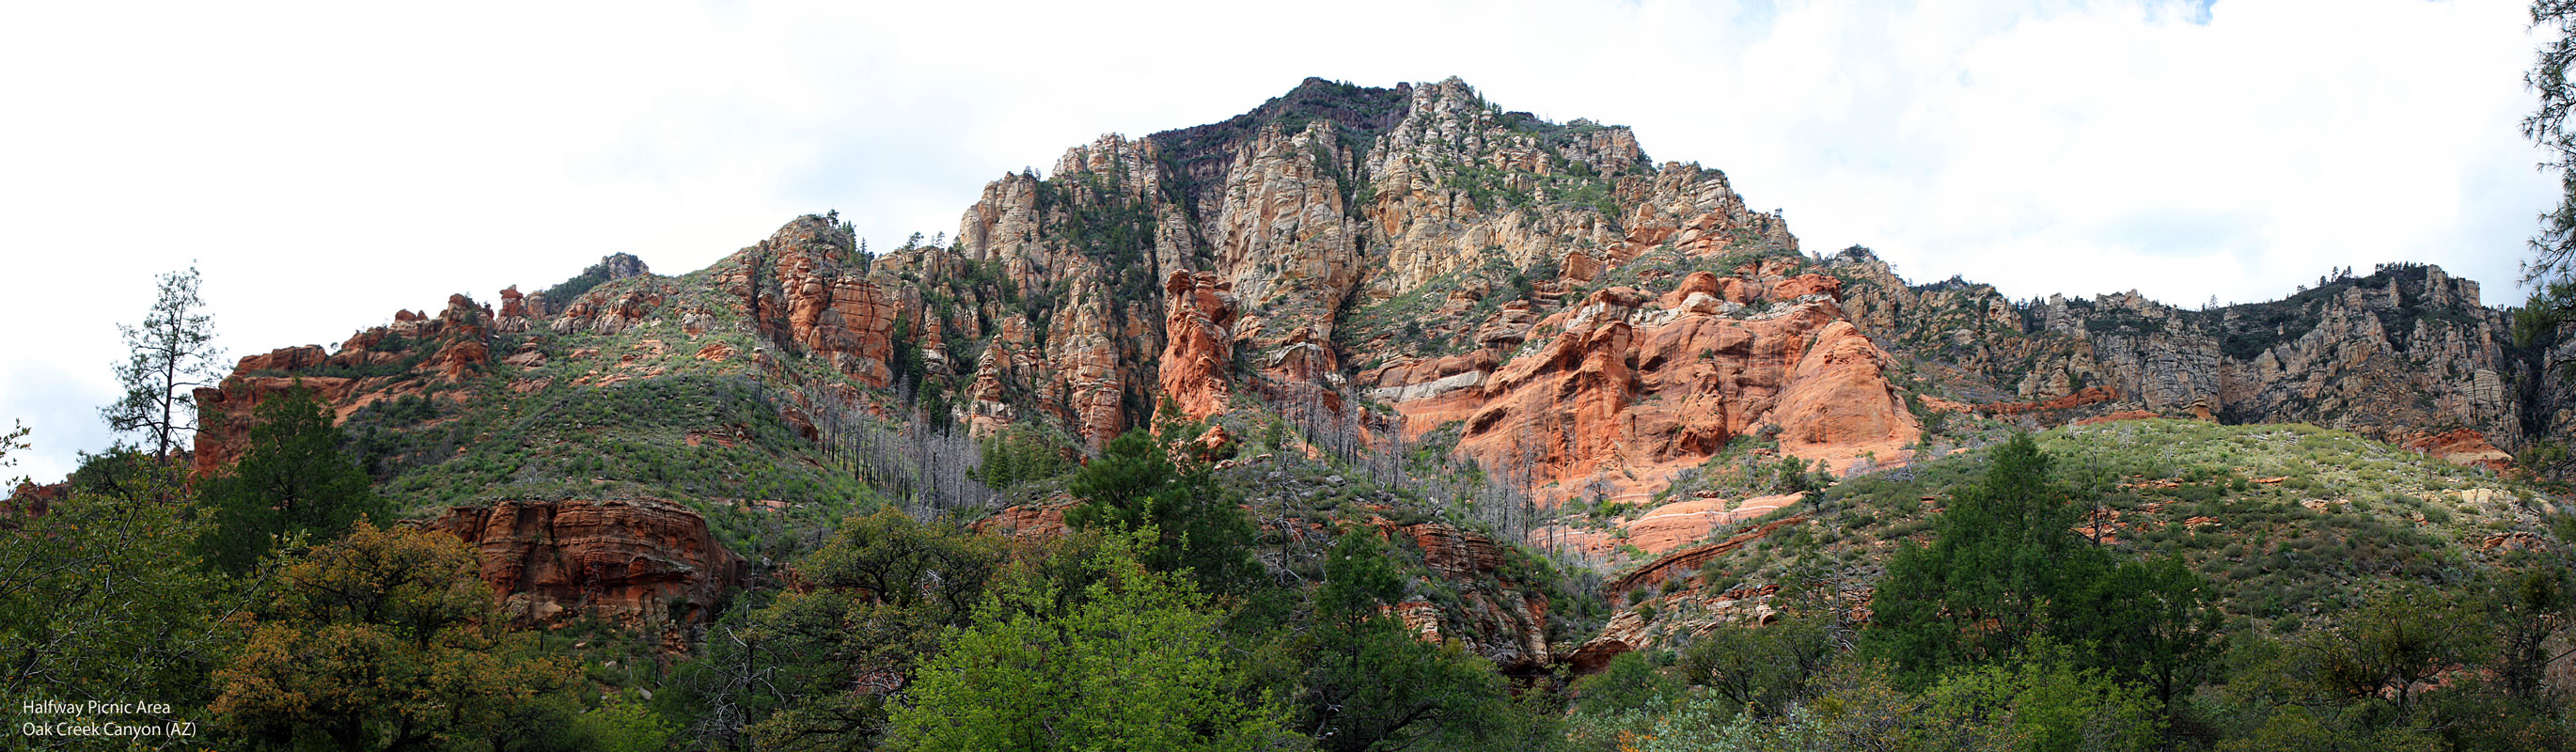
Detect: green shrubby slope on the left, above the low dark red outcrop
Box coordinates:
(348, 271, 873, 554)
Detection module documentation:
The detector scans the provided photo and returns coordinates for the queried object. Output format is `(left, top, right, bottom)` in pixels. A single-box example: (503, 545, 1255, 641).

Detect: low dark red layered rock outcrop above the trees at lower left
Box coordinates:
(428, 500, 745, 623)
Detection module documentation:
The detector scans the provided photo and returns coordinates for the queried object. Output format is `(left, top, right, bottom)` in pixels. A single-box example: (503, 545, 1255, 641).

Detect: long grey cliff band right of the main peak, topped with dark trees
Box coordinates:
(1829, 250, 2566, 458)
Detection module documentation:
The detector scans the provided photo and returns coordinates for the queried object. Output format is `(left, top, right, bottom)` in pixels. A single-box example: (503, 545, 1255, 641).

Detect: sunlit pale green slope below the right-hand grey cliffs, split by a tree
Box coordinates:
(1708, 420, 2555, 631)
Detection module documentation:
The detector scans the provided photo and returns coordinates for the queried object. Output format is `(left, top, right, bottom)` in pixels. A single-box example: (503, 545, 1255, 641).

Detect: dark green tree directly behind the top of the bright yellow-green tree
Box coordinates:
(1064, 422, 1260, 595)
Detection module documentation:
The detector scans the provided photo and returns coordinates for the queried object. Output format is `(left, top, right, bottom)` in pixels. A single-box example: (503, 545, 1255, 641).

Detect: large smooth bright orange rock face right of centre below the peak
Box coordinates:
(1362, 268, 1922, 500)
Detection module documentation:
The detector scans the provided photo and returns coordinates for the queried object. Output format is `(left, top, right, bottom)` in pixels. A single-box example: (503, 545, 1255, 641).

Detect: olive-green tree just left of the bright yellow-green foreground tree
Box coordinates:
(749, 509, 1002, 749)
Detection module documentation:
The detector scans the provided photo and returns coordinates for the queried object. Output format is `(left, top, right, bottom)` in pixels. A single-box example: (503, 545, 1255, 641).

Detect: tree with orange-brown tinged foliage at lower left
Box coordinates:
(212, 520, 574, 749)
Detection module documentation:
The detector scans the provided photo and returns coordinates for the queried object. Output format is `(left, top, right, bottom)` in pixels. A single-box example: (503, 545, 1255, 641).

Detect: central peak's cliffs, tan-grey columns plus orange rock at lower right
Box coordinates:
(917, 80, 1864, 487)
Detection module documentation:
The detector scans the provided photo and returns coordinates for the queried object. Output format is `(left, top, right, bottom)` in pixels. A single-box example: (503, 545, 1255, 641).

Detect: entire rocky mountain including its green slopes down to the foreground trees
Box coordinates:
(110, 80, 2576, 749)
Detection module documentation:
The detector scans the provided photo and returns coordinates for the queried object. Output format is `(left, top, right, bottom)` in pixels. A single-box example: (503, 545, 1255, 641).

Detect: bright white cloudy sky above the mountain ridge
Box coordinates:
(0, 0, 2555, 479)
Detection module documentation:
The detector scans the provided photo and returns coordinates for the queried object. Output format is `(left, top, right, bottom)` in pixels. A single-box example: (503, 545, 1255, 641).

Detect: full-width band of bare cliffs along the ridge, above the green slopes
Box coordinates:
(198, 80, 2576, 545)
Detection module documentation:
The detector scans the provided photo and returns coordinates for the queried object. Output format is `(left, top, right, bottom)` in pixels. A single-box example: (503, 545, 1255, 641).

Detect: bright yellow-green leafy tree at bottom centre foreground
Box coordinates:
(888, 533, 1280, 752)
